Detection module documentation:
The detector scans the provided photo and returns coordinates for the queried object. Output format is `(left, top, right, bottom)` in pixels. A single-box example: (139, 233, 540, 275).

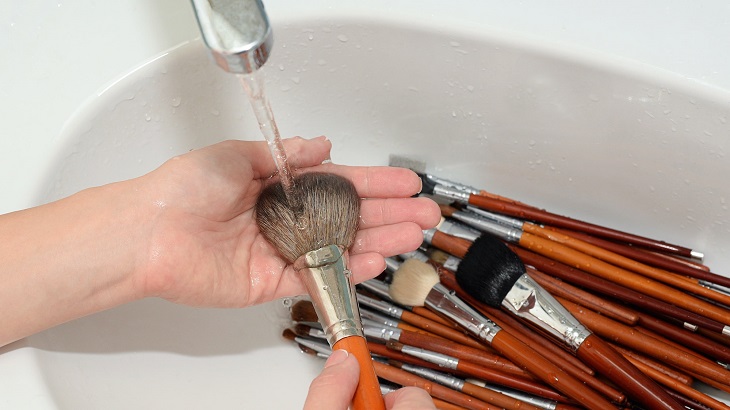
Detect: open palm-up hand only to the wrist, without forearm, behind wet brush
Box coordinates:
(131, 137, 440, 306)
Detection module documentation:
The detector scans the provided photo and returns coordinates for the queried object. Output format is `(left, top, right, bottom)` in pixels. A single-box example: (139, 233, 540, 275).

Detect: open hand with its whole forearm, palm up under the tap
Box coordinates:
(0, 137, 440, 346)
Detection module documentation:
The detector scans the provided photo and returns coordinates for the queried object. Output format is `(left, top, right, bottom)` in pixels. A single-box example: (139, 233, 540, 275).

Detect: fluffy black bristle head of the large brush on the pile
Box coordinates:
(456, 234, 525, 307)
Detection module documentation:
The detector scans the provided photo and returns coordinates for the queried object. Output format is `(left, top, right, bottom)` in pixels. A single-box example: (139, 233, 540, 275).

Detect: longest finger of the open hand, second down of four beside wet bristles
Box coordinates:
(360, 198, 441, 229)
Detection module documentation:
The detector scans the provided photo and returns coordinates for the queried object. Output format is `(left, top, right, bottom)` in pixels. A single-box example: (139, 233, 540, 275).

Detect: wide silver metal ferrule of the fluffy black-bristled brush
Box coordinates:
(502, 274, 591, 351)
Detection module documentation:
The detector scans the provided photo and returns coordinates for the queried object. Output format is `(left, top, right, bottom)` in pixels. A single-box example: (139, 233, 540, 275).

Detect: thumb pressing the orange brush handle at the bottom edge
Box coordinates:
(304, 350, 360, 410)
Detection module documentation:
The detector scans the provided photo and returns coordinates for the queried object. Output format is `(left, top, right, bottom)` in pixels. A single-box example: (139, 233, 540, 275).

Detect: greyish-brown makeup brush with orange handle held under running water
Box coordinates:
(255, 173, 385, 410)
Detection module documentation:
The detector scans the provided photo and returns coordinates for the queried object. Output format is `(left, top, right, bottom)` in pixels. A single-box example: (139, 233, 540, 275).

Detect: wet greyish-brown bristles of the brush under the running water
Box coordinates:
(256, 172, 360, 263)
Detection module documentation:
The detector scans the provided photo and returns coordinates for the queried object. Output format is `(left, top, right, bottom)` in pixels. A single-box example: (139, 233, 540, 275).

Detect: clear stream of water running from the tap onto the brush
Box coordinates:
(239, 69, 294, 198)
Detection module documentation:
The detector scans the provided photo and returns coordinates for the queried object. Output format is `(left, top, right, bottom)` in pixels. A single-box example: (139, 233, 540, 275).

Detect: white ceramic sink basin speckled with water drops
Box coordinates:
(0, 2, 730, 409)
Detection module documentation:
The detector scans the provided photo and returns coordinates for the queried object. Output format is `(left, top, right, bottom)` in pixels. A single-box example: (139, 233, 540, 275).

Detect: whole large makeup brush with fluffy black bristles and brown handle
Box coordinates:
(456, 234, 683, 410)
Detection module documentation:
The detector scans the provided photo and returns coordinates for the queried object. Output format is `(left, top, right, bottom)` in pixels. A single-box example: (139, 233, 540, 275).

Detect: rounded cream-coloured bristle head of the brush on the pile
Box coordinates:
(389, 258, 439, 306)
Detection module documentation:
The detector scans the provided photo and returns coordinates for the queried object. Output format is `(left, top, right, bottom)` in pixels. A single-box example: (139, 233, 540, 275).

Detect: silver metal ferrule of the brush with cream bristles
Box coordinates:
(426, 283, 502, 343)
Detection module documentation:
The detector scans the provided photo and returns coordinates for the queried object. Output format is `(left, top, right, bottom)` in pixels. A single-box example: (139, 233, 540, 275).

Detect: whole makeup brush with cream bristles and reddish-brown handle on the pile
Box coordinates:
(390, 259, 615, 410)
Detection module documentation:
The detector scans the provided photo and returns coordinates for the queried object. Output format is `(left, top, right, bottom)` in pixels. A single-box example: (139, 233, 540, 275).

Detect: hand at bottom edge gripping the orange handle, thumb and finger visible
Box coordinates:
(304, 350, 436, 410)
